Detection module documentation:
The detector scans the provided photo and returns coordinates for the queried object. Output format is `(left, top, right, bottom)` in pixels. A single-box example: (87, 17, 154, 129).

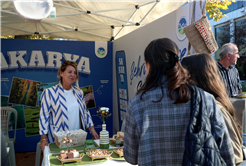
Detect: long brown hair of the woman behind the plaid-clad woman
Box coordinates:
(181, 54, 242, 136)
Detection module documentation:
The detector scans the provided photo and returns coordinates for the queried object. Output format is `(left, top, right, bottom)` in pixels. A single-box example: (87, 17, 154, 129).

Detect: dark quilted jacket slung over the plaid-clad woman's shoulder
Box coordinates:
(182, 87, 226, 166)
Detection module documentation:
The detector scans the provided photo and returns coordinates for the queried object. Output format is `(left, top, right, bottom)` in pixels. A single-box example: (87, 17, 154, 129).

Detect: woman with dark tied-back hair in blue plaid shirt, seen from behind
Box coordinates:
(124, 38, 235, 166)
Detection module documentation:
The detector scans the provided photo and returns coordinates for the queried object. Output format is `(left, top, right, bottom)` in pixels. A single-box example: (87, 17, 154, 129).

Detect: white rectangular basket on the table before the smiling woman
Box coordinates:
(54, 129, 87, 148)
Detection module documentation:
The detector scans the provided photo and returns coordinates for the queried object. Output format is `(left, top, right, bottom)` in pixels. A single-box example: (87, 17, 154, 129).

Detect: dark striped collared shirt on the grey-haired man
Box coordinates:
(218, 62, 242, 97)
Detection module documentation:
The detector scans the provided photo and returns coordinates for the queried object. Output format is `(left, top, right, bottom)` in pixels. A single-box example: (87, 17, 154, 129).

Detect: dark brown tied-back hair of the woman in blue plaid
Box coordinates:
(137, 38, 193, 104)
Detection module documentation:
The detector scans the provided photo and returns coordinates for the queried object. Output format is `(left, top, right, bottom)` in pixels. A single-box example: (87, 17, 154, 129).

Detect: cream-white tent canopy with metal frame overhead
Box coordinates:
(0, 0, 189, 41)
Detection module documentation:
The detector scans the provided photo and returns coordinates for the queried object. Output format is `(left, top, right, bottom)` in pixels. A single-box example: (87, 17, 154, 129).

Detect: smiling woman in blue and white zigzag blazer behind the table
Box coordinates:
(39, 61, 99, 151)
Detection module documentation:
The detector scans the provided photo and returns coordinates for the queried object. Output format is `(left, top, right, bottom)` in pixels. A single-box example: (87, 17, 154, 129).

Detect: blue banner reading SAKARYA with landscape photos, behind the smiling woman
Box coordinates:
(0, 39, 113, 152)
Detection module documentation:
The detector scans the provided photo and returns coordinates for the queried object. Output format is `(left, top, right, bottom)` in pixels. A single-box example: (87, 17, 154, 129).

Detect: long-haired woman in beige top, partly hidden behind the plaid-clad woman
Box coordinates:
(182, 54, 243, 165)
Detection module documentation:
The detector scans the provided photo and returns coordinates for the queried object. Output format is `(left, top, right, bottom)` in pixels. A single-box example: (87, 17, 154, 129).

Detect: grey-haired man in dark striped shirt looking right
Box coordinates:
(218, 43, 242, 97)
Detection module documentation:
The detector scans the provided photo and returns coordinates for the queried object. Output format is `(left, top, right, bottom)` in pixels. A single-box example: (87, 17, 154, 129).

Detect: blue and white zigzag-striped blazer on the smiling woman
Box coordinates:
(39, 83, 94, 143)
